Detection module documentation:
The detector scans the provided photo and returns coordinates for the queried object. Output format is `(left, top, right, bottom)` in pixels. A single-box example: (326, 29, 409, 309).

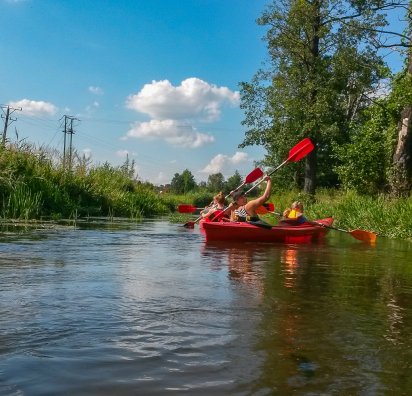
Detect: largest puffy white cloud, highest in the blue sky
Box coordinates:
(126, 77, 240, 121)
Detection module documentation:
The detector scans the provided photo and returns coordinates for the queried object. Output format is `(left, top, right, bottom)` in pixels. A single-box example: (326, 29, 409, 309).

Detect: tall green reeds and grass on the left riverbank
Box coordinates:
(0, 143, 168, 220)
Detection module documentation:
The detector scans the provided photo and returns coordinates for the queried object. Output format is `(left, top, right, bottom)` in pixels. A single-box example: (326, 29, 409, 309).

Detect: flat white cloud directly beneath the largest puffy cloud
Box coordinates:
(124, 120, 215, 148)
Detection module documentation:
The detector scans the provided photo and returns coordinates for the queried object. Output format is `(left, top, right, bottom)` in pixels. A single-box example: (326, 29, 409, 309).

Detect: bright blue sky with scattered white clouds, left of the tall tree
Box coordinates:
(0, 0, 406, 184)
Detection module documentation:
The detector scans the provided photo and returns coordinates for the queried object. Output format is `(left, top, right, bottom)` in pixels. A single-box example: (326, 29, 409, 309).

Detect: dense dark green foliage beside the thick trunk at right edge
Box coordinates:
(334, 73, 412, 194)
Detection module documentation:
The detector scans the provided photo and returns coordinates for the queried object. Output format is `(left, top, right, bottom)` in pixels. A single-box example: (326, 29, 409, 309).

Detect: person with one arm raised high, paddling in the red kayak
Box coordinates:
(226, 175, 272, 221)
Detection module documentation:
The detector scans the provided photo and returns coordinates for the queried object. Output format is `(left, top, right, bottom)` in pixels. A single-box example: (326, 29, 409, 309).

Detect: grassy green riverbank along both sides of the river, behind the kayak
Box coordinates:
(0, 145, 412, 240)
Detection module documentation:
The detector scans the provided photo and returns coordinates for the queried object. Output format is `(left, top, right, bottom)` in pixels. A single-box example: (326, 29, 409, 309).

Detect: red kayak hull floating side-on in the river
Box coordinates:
(202, 217, 333, 243)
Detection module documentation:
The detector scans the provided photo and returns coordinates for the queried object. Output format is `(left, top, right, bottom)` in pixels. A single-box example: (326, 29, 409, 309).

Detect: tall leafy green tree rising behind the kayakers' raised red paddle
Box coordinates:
(240, 0, 387, 194)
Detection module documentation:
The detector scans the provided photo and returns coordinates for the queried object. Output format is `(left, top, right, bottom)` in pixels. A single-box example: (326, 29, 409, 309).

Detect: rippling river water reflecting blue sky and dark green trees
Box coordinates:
(0, 219, 412, 396)
